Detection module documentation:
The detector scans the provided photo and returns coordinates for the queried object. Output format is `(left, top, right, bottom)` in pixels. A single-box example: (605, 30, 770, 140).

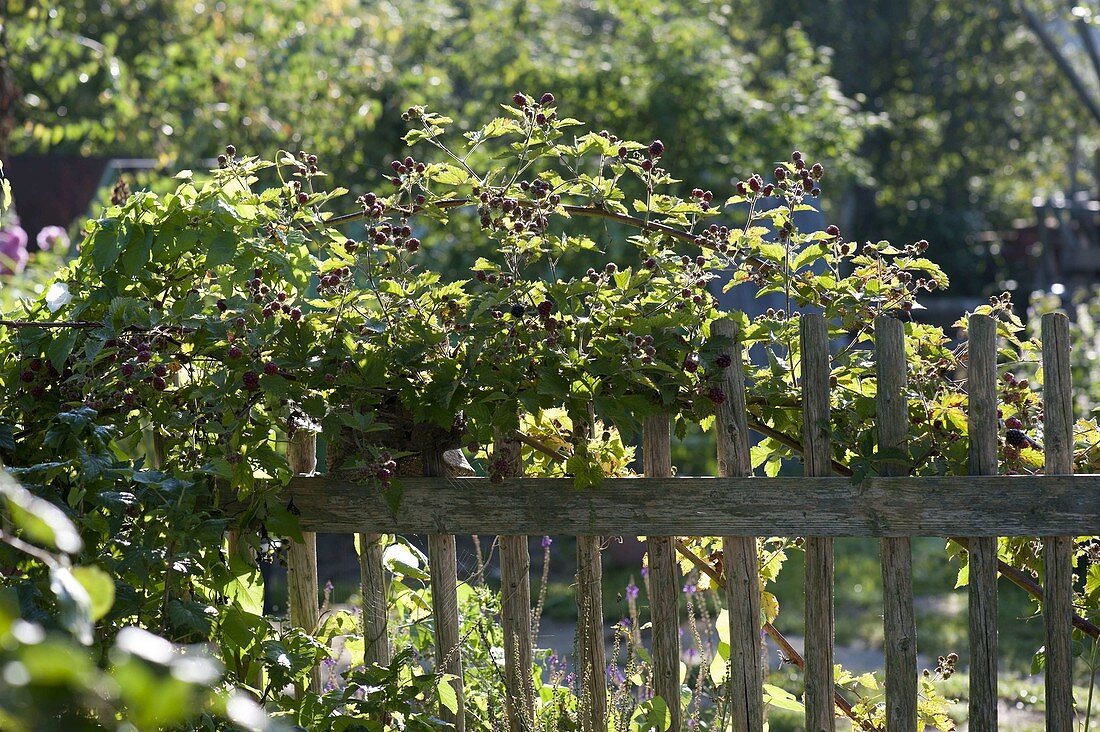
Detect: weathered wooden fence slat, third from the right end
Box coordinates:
(875, 317, 916, 730)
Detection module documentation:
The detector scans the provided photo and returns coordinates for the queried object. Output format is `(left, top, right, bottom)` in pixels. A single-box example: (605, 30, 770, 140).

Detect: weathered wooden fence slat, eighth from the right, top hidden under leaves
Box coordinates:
(493, 431, 535, 732)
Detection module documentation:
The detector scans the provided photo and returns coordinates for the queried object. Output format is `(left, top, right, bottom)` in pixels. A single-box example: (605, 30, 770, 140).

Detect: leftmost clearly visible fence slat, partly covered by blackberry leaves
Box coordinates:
(286, 430, 321, 692)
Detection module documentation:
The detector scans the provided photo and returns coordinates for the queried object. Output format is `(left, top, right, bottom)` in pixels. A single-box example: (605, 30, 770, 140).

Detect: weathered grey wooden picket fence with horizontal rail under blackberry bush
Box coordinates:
(270, 314, 1100, 732)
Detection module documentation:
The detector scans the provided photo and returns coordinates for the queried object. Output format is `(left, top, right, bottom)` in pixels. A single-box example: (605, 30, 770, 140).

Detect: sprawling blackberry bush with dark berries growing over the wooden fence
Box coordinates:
(0, 92, 1100, 730)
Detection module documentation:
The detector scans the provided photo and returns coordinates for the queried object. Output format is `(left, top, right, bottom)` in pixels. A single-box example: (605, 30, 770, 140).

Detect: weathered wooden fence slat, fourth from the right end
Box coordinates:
(800, 314, 836, 732)
